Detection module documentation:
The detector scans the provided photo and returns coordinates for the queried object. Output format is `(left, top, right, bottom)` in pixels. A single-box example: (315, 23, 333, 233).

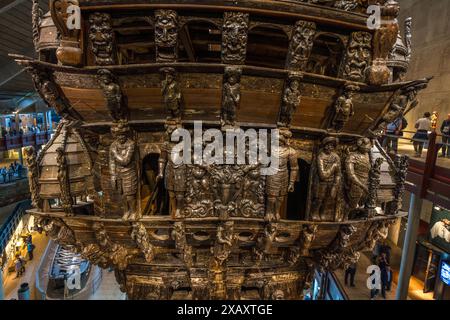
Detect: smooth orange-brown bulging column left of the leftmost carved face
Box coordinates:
(50, 0, 83, 66)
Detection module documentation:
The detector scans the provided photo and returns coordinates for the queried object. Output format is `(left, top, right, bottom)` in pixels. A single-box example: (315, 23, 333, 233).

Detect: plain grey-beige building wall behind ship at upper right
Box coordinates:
(399, 0, 450, 130)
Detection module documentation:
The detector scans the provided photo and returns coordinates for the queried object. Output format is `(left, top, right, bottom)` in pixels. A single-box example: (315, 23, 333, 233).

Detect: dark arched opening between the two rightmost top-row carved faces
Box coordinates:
(306, 34, 345, 77)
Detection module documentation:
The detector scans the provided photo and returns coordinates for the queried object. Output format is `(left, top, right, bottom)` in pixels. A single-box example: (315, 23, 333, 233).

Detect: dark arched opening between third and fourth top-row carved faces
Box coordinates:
(246, 26, 289, 69)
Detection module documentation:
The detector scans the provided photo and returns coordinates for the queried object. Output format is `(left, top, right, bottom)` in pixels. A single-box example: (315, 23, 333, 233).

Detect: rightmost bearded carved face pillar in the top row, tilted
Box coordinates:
(342, 31, 372, 82)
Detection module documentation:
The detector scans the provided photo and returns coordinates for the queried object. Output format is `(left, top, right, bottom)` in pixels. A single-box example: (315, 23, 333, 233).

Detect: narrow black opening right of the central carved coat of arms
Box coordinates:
(285, 159, 311, 220)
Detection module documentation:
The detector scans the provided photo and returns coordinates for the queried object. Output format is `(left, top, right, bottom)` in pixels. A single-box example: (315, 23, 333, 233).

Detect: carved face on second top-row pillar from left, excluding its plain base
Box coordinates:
(155, 10, 178, 47)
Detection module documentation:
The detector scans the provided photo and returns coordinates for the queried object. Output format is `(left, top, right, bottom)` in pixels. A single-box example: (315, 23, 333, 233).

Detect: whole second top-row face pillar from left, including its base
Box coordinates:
(155, 10, 178, 62)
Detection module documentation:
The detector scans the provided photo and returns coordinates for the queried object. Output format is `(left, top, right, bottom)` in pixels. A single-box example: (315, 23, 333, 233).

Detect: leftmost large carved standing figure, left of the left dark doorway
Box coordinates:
(109, 121, 137, 220)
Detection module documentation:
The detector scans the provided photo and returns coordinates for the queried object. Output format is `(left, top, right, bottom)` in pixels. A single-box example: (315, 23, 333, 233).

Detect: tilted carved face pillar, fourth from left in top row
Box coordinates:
(287, 21, 316, 71)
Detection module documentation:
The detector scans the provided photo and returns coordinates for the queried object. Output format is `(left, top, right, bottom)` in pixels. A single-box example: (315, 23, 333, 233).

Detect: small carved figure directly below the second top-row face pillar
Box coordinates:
(161, 68, 181, 119)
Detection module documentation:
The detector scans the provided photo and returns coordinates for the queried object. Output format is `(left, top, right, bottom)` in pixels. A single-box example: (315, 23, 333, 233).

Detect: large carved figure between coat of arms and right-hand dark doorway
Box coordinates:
(266, 129, 299, 221)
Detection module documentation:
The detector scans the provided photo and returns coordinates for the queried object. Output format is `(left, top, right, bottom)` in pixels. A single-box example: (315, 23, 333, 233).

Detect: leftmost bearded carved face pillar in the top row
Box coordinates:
(89, 12, 115, 66)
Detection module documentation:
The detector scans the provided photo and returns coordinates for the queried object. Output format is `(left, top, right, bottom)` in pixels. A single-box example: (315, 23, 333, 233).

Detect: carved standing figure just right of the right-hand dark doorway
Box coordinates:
(311, 137, 341, 221)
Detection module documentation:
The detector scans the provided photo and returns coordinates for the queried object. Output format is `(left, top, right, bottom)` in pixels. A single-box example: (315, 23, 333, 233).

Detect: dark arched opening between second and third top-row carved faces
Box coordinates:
(178, 20, 222, 63)
